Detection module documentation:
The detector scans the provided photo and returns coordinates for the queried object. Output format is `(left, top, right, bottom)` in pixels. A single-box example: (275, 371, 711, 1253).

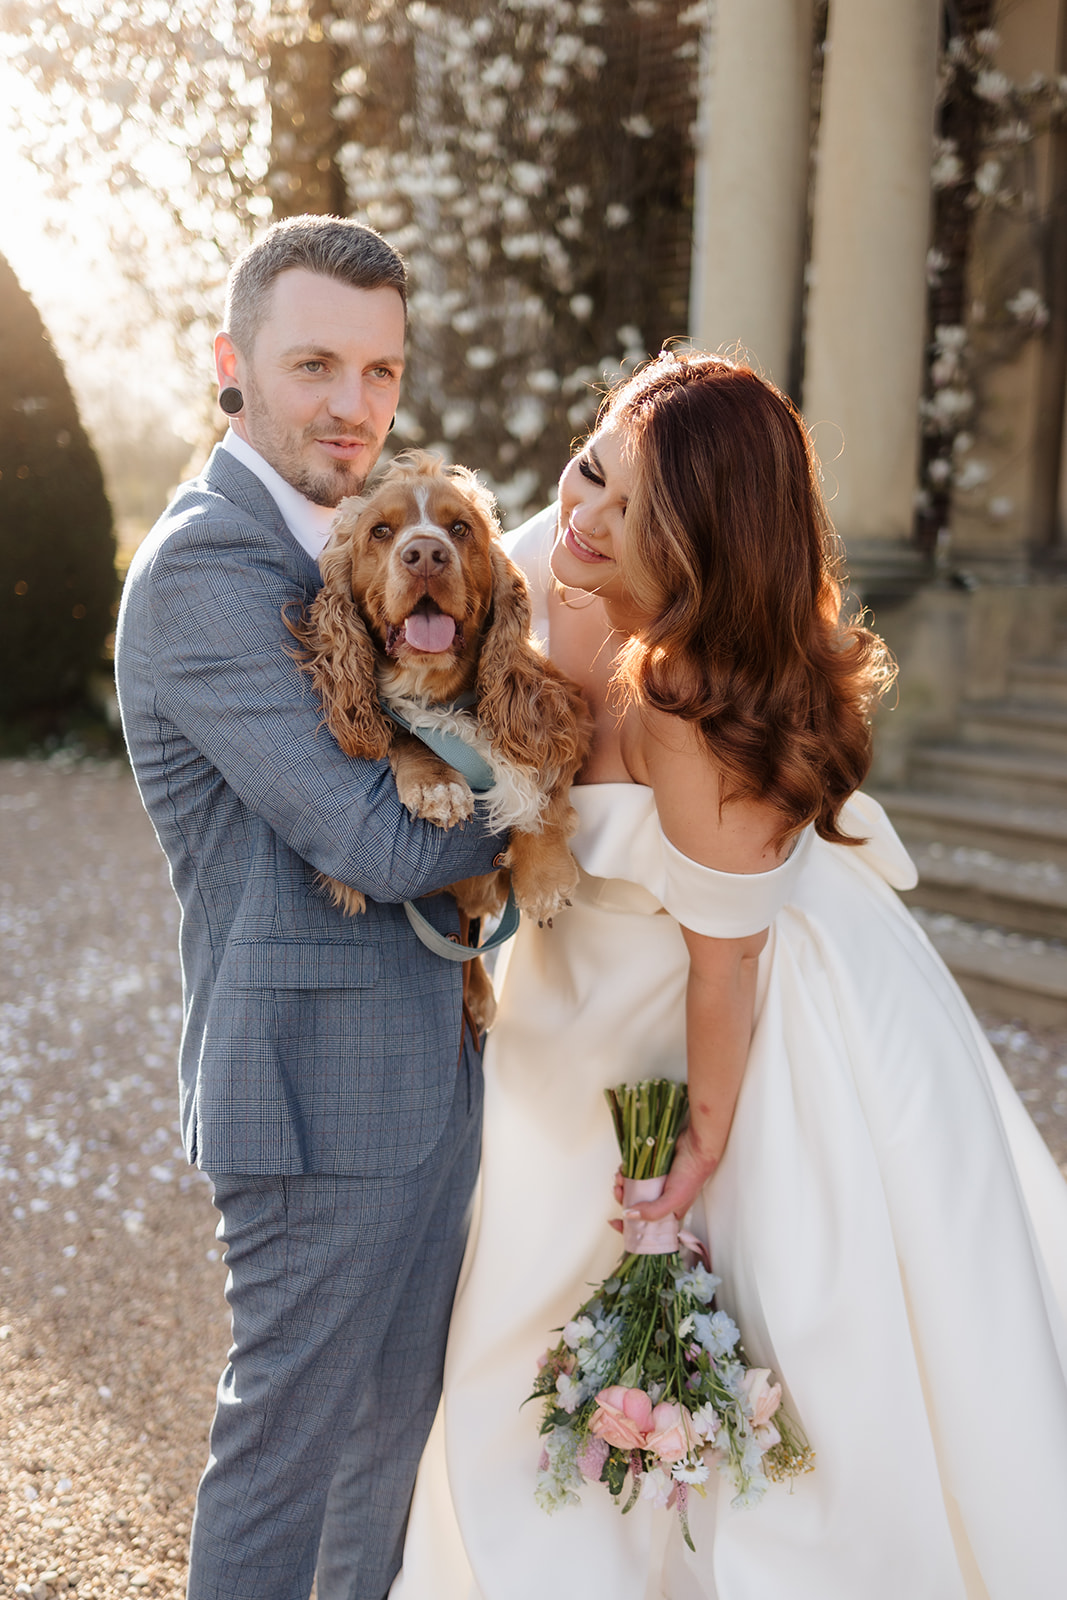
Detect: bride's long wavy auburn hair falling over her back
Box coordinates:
(600, 352, 896, 843)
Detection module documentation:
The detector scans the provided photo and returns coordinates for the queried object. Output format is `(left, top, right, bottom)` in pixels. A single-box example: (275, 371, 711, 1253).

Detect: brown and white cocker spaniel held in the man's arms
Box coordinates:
(290, 450, 590, 1027)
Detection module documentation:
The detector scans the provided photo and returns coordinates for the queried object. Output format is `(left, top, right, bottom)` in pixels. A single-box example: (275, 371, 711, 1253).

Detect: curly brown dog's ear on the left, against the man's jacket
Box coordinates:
(288, 526, 394, 762)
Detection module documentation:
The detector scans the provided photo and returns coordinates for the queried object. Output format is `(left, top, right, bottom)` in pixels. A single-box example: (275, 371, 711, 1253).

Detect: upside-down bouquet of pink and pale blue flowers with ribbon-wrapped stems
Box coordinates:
(531, 1078, 814, 1549)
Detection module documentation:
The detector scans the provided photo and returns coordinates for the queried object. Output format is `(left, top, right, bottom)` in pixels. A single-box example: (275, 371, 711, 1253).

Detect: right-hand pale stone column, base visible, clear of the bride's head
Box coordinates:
(803, 0, 939, 594)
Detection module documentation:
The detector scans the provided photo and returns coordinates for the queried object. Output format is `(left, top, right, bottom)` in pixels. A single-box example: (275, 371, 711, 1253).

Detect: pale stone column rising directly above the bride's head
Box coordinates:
(689, 0, 812, 386)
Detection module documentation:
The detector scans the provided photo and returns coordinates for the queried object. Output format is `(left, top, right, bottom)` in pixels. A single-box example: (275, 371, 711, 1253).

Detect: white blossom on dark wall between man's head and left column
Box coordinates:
(319, 0, 705, 517)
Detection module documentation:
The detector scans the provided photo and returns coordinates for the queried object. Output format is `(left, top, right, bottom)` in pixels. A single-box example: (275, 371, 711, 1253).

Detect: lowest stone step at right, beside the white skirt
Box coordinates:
(913, 907, 1067, 1027)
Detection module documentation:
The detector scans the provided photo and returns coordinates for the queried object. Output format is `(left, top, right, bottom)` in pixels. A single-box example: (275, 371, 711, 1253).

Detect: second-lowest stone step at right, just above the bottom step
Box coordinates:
(904, 840, 1067, 941)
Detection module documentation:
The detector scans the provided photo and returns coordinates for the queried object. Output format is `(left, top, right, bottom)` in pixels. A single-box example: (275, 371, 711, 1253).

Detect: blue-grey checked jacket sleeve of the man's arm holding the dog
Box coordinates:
(133, 502, 501, 902)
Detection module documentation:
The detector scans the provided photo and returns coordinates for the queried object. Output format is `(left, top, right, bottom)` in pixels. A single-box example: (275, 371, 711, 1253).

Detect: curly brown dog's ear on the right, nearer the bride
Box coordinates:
(478, 542, 589, 789)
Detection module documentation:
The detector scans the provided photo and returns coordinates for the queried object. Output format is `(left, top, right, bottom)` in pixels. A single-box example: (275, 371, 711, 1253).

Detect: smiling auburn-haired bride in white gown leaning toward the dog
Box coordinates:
(390, 354, 1067, 1600)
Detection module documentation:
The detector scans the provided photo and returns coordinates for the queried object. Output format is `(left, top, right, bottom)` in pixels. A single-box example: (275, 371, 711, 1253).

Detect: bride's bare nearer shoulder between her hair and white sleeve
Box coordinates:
(625, 706, 784, 872)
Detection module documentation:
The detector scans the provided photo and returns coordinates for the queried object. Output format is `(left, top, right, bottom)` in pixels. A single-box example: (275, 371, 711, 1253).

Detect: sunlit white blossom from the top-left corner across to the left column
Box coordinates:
(0, 0, 707, 515)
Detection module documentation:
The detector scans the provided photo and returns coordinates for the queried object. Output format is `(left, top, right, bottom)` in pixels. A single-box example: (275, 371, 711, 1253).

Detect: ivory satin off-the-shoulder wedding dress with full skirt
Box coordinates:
(392, 517, 1067, 1600)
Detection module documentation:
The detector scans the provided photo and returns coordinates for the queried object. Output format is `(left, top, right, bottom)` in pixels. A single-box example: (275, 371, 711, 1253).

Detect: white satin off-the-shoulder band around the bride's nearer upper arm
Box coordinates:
(657, 827, 813, 939)
